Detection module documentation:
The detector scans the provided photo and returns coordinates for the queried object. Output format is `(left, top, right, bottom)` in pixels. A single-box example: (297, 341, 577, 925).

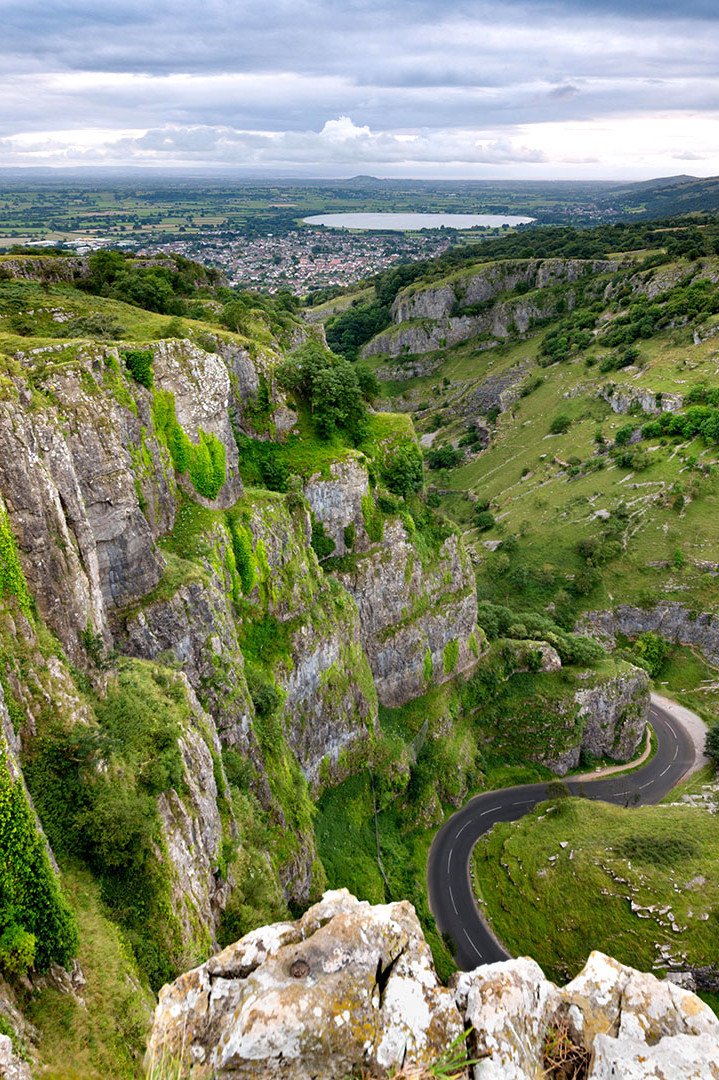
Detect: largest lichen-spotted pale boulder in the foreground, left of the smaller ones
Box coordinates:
(147, 889, 462, 1080)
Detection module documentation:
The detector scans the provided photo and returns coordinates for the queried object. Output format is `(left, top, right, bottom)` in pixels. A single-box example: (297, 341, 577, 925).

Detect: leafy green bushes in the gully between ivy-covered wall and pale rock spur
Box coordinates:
(25, 660, 190, 988)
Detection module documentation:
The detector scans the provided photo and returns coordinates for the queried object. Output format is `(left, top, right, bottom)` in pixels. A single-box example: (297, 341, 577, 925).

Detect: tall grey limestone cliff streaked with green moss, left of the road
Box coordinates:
(0, 326, 477, 960)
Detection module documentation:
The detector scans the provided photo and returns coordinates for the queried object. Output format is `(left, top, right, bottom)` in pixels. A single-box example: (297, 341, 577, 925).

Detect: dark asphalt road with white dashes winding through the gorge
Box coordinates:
(428, 694, 703, 971)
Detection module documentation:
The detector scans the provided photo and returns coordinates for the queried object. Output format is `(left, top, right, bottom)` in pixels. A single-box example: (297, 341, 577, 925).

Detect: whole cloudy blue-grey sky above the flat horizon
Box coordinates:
(0, 0, 719, 180)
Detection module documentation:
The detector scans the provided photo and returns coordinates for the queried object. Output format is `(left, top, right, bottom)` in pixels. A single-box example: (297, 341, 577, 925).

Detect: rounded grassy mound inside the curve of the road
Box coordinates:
(474, 799, 719, 982)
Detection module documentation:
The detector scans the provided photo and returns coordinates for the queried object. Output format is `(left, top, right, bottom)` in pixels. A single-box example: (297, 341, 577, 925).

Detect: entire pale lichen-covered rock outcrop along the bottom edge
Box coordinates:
(146, 889, 719, 1080)
